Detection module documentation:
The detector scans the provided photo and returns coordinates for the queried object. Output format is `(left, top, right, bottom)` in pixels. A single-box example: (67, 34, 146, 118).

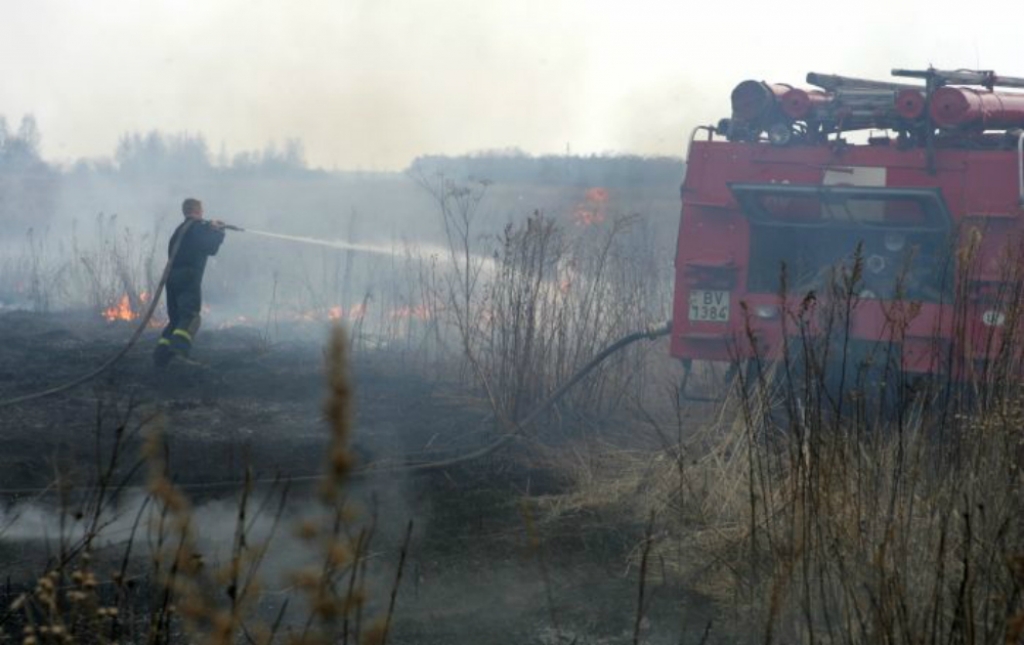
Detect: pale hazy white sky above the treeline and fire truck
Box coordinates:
(0, 0, 1024, 170)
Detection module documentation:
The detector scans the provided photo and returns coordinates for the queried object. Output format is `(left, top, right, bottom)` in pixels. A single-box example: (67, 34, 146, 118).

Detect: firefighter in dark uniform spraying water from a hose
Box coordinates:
(153, 198, 224, 369)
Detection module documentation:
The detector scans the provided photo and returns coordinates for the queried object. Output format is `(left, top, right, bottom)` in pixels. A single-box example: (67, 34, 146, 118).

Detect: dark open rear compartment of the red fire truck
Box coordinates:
(730, 184, 951, 302)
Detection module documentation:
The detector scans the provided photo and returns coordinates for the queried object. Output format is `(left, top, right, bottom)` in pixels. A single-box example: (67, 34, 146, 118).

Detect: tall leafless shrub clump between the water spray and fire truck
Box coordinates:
(418, 175, 671, 434)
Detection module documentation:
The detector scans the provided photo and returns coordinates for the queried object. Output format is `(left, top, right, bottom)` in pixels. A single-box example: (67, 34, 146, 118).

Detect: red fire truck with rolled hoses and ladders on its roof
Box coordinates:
(671, 69, 1024, 387)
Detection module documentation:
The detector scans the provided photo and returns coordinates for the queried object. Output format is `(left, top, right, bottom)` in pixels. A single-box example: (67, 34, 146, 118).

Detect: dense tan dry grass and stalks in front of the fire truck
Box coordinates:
(546, 248, 1024, 643)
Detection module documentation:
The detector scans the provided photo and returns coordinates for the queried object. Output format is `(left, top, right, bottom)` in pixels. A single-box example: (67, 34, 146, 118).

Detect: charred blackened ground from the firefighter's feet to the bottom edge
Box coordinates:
(0, 312, 708, 643)
